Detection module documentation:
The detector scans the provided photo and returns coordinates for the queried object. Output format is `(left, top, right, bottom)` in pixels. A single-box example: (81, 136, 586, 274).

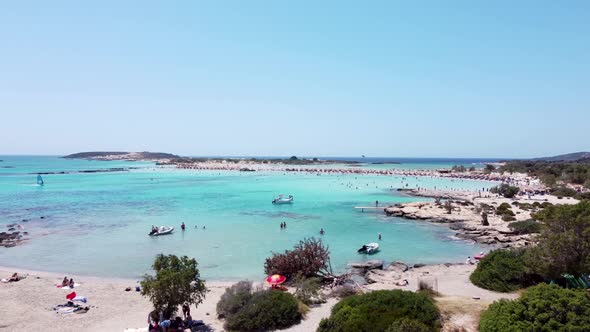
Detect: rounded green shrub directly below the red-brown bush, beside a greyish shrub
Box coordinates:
(225, 290, 302, 331)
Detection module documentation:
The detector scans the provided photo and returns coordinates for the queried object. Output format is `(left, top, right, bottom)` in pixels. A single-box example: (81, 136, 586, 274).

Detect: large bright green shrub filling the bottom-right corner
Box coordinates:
(479, 284, 590, 332)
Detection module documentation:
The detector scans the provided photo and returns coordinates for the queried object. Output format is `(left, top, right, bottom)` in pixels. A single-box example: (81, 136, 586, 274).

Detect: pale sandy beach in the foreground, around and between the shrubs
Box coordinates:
(0, 265, 518, 332)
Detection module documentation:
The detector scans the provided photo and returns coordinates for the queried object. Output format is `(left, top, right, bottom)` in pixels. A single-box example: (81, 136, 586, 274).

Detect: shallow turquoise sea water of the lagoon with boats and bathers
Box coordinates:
(0, 156, 493, 280)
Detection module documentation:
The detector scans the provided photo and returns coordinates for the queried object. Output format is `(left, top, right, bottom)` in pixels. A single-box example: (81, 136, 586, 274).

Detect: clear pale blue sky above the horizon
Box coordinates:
(0, 0, 590, 157)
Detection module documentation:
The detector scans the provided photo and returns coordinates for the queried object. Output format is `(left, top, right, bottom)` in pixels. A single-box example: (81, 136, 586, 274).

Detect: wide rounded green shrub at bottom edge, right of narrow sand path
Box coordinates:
(317, 290, 440, 332)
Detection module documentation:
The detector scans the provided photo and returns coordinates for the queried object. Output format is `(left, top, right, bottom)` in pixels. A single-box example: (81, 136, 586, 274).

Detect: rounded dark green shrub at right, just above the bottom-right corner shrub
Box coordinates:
(469, 249, 527, 292)
